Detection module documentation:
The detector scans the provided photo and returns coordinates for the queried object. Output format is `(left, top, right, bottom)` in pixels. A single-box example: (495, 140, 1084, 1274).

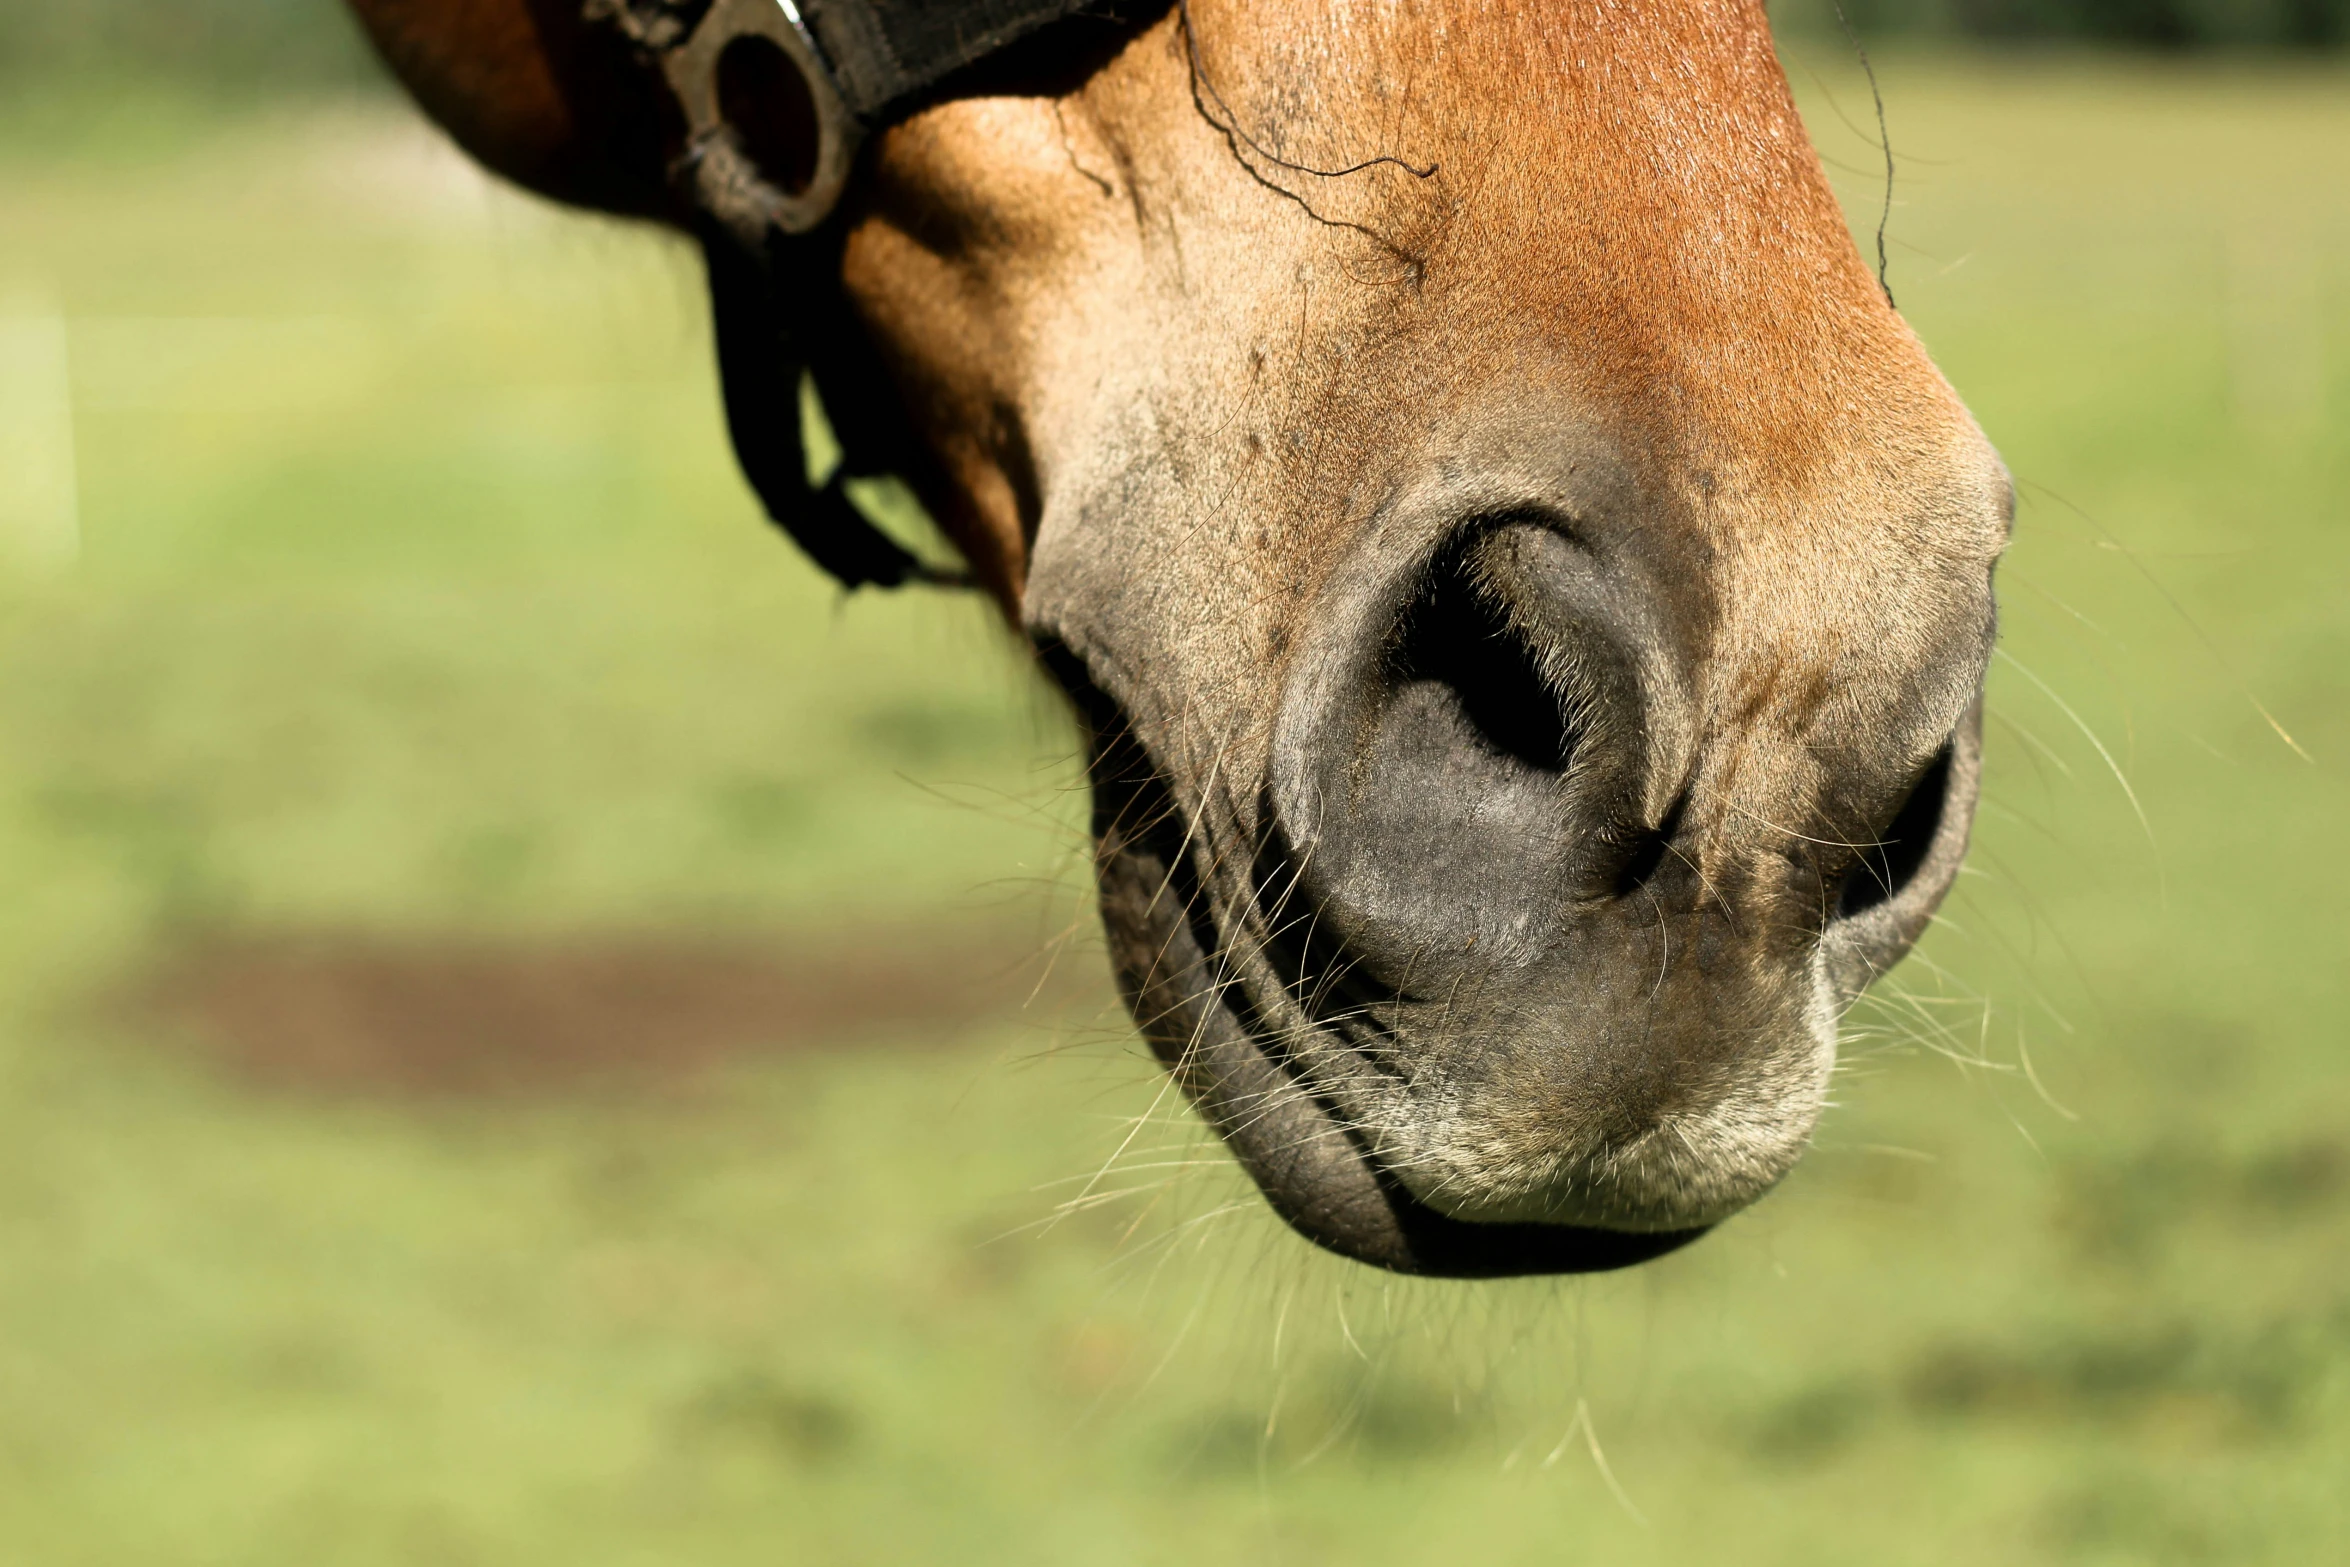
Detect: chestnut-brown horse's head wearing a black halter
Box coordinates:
(353, 0, 2014, 1278)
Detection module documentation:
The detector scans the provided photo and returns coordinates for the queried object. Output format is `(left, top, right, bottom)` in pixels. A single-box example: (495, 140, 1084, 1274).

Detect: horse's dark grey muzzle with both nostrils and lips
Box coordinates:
(1062, 434, 1981, 1276)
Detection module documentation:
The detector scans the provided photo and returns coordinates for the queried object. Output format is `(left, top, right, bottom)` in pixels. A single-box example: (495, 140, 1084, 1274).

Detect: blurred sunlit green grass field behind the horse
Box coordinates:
(0, 56, 2350, 1567)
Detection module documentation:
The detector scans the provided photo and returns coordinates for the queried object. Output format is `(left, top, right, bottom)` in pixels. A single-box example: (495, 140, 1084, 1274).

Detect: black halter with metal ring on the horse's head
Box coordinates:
(596, 0, 1114, 590)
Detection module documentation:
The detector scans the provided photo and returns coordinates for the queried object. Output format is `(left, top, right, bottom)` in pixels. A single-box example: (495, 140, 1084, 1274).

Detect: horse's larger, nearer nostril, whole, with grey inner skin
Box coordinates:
(1269, 512, 1678, 994)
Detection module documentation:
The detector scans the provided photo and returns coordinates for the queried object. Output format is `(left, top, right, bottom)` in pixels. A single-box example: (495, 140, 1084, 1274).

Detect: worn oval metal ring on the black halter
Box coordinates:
(663, 0, 865, 249)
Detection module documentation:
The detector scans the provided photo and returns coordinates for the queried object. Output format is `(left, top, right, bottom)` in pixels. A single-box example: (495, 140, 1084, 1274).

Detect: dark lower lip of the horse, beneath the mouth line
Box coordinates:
(1043, 644, 1704, 1278)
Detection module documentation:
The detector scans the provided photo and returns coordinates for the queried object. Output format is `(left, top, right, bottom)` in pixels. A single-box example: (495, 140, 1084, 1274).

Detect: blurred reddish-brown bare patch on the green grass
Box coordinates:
(127, 926, 1109, 1097)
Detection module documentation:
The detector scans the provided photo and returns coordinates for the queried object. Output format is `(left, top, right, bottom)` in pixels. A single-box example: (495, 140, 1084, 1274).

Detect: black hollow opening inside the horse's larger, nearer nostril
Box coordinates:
(1387, 533, 1577, 773)
